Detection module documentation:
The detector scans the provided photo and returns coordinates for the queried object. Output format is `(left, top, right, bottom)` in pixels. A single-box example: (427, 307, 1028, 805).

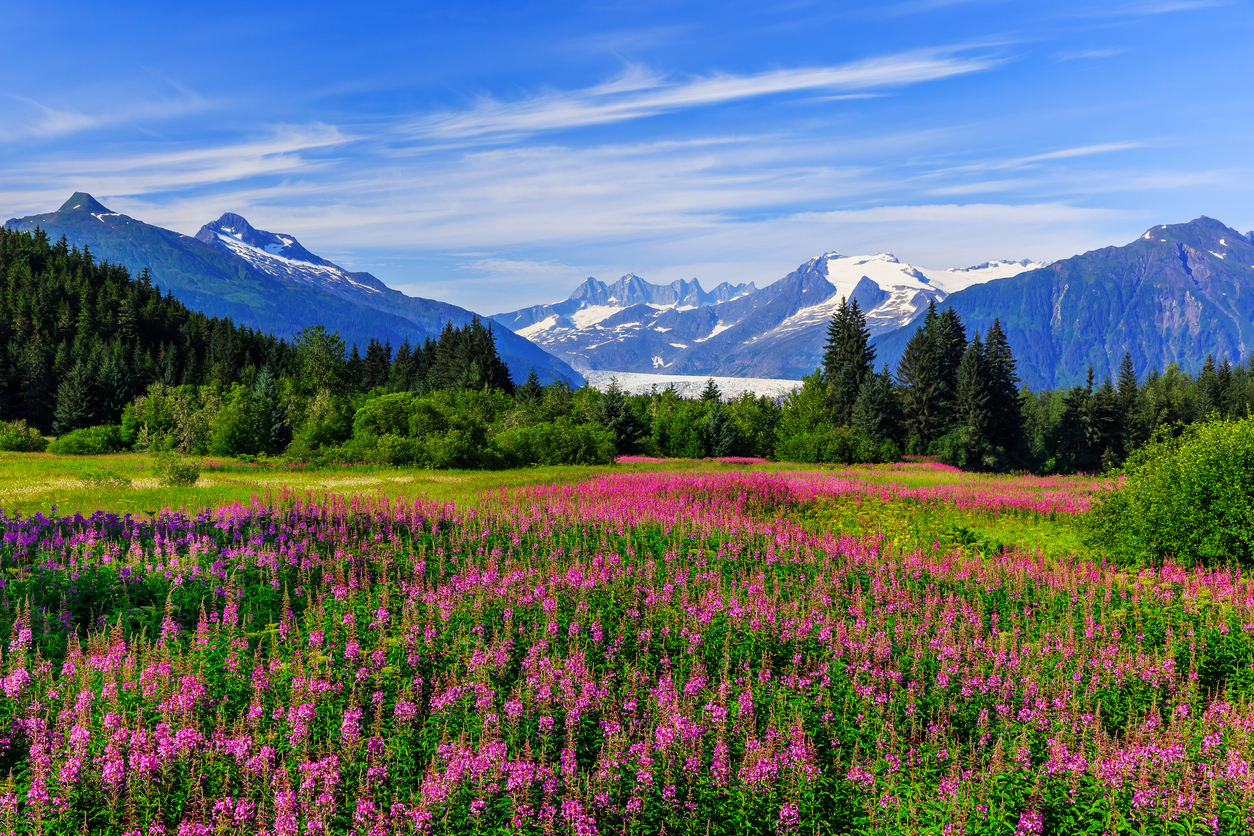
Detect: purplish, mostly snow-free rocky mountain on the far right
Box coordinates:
(877, 217, 1254, 389)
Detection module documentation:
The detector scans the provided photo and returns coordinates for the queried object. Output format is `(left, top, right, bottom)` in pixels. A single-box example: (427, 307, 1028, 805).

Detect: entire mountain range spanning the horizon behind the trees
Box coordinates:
(5, 192, 1254, 389)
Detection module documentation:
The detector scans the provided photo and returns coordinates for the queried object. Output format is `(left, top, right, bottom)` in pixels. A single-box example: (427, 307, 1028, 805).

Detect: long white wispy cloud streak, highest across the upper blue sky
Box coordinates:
(411, 50, 1001, 140)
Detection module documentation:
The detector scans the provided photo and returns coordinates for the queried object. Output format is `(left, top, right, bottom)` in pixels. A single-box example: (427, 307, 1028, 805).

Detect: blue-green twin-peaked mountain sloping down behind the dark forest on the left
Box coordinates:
(5, 192, 581, 384)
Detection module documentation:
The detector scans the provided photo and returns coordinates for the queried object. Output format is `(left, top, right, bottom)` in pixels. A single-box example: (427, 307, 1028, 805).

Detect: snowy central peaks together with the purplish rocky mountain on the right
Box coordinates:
(494, 217, 1254, 390)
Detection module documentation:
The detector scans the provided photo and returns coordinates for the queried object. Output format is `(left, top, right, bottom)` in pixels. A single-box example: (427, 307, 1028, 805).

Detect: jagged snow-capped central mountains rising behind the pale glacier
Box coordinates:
(493, 253, 1040, 379)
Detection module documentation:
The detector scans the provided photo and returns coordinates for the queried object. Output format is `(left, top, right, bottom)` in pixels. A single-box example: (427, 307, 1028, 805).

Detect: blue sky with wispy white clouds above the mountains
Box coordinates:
(0, 0, 1254, 313)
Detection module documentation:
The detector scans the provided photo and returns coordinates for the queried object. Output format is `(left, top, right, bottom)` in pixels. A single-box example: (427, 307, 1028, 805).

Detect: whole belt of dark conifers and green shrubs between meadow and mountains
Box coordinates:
(0, 221, 1254, 473)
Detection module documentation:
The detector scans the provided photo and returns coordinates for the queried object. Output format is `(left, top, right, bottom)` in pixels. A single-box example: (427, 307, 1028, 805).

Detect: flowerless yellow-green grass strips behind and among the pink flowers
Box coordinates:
(0, 452, 1098, 555)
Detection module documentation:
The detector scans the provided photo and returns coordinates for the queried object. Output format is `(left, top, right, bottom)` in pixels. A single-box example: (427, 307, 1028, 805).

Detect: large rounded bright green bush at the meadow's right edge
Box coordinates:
(1085, 419, 1254, 563)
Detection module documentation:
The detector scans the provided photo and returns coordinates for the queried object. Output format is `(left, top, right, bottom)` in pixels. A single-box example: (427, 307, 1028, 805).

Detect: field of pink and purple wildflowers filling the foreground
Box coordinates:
(0, 465, 1254, 836)
